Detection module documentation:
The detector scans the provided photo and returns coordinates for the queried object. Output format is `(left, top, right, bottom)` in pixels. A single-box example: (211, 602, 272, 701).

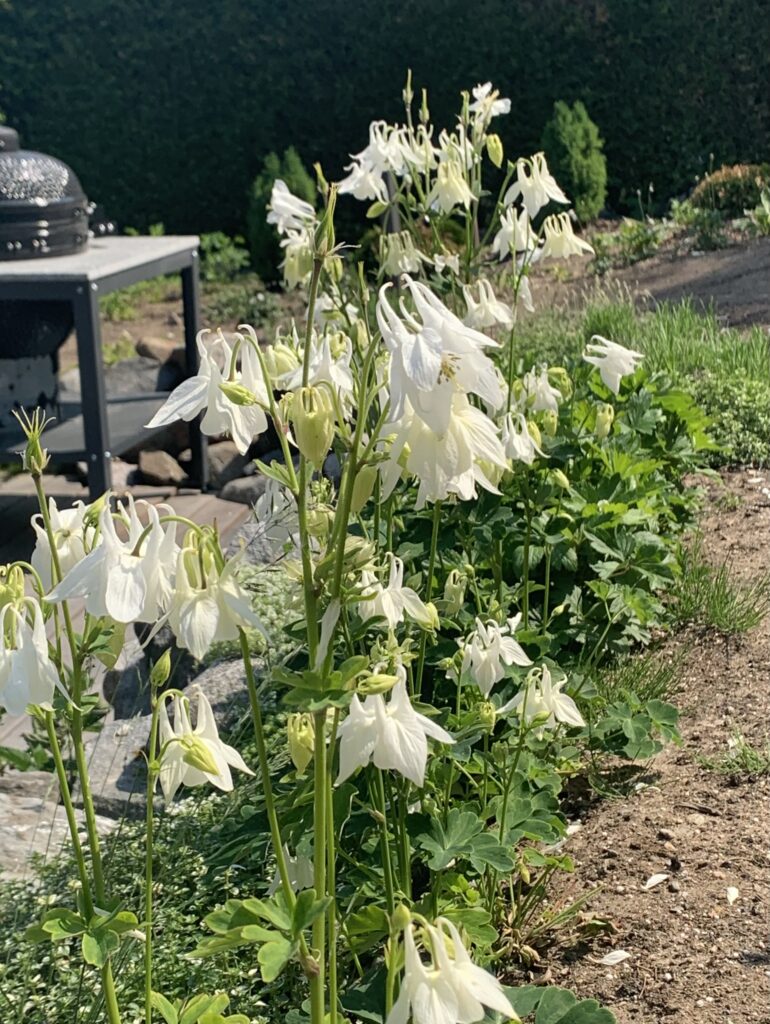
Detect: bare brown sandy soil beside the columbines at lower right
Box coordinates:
(532, 471, 770, 1024)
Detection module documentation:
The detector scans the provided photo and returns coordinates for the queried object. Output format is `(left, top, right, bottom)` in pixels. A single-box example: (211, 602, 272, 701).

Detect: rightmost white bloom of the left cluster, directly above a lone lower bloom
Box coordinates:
(168, 546, 264, 662)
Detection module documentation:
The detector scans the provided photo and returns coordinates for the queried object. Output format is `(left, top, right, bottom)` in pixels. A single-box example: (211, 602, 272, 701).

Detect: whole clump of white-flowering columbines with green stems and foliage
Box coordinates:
(0, 75, 713, 1024)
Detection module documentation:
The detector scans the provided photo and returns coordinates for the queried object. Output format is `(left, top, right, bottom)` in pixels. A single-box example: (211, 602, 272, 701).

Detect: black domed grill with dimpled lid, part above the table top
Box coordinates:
(0, 125, 88, 260)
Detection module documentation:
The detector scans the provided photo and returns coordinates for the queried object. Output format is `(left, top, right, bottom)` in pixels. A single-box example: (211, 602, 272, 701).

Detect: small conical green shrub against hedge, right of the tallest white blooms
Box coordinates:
(543, 99, 607, 223)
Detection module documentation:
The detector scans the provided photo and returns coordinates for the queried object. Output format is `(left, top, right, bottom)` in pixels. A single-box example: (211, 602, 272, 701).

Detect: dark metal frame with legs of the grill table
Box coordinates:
(0, 236, 208, 500)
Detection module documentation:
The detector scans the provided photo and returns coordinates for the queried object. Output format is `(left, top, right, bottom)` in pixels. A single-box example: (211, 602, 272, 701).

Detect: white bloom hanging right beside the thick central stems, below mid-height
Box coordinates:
(337, 666, 455, 786)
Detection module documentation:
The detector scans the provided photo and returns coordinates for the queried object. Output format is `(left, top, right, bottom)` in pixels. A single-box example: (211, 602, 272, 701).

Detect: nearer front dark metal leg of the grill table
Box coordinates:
(73, 284, 112, 501)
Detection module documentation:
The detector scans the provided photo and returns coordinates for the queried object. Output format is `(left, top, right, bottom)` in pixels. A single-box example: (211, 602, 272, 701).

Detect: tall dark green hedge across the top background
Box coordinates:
(0, 0, 770, 230)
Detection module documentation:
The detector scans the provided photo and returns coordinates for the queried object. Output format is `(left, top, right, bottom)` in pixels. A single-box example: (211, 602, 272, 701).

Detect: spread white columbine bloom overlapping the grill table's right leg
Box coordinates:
(147, 330, 267, 455)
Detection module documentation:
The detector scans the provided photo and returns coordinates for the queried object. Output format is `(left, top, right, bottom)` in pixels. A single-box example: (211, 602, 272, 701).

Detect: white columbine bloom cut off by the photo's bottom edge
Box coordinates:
(385, 918, 518, 1024)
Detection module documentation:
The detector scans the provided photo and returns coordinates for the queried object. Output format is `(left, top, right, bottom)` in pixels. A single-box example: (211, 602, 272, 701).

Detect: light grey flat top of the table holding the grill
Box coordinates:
(0, 234, 200, 283)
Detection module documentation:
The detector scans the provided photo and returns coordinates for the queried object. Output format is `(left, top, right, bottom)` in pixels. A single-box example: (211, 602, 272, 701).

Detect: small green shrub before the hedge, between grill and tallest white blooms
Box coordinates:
(246, 145, 315, 283)
